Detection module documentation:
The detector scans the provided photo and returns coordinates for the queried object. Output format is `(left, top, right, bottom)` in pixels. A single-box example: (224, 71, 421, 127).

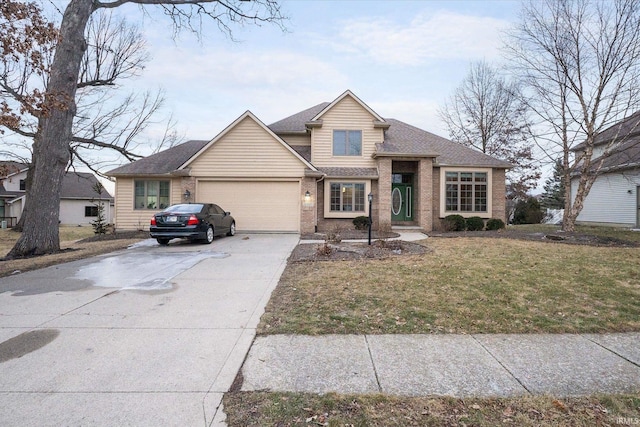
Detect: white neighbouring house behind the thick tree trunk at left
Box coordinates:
(0, 161, 113, 227)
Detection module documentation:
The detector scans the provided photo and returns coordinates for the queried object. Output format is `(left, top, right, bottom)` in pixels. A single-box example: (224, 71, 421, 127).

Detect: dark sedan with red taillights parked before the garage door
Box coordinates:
(149, 203, 236, 245)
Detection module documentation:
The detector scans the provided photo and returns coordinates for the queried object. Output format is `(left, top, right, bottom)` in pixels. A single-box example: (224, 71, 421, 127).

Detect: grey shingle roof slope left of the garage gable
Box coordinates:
(107, 140, 209, 176)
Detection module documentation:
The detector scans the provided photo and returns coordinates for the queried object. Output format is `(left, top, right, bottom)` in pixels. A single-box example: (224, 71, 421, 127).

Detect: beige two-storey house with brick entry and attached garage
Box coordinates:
(107, 91, 510, 233)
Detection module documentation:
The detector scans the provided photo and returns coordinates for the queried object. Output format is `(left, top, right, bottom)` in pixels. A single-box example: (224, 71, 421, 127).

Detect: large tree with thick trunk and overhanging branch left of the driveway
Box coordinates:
(7, 0, 283, 258)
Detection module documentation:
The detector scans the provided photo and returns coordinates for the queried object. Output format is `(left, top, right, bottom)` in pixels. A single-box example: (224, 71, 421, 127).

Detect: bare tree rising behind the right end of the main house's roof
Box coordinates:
(438, 61, 540, 198)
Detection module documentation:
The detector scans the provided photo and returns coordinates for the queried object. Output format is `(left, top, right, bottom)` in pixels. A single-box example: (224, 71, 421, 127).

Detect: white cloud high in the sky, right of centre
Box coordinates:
(333, 11, 509, 65)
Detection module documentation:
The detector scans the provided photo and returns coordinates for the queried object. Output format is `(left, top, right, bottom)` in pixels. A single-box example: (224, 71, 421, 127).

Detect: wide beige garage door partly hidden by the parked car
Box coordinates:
(197, 181, 300, 232)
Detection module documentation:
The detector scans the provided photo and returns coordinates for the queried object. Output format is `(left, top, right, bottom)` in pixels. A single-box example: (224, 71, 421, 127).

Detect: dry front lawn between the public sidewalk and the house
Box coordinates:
(258, 238, 640, 335)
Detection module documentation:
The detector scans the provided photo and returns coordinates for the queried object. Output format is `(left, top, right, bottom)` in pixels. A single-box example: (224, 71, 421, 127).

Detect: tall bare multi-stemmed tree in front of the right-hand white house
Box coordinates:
(506, 0, 640, 231)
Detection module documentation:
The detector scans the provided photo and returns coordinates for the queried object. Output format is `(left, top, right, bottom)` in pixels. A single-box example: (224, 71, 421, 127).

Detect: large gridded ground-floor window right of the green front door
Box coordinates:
(445, 172, 488, 212)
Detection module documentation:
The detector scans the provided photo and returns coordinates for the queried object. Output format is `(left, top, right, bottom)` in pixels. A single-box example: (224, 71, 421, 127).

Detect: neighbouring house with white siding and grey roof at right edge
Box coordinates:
(571, 111, 640, 227)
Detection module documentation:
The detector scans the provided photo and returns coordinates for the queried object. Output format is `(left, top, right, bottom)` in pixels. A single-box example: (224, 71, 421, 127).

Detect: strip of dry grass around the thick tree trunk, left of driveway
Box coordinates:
(0, 227, 146, 277)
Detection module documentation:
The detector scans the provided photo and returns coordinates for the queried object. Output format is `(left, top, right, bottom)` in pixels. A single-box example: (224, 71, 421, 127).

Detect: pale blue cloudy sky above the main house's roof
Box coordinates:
(107, 0, 519, 157)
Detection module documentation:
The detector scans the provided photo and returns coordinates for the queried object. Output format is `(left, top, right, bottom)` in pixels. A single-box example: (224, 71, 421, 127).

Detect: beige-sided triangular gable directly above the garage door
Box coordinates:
(183, 113, 310, 178)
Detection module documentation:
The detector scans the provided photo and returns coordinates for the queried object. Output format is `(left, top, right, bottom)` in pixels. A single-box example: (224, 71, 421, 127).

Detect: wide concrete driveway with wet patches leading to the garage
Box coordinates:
(0, 234, 298, 426)
